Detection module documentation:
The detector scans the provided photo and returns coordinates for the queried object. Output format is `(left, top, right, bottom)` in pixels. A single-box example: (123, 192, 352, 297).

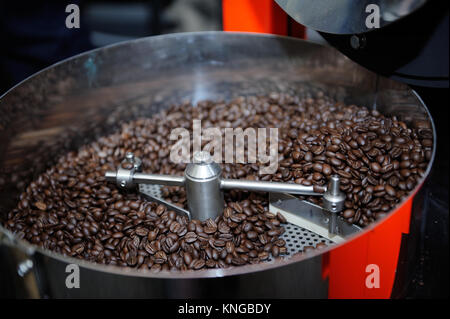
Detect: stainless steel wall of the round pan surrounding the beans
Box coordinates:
(0, 32, 434, 298)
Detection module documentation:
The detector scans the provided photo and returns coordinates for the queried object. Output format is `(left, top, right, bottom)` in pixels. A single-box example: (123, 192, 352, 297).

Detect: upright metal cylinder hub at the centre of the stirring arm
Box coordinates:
(184, 152, 224, 220)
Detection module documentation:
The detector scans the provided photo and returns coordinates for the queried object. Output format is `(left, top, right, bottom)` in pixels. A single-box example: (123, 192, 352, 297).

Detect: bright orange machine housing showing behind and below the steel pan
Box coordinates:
(222, 0, 413, 298)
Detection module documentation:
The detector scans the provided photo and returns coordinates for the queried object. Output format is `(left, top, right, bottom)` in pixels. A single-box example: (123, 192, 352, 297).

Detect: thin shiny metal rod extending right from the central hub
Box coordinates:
(220, 179, 323, 196)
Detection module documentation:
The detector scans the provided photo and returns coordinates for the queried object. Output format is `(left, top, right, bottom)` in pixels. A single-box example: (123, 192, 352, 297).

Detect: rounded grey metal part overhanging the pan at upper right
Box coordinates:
(275, 0, 427, 34)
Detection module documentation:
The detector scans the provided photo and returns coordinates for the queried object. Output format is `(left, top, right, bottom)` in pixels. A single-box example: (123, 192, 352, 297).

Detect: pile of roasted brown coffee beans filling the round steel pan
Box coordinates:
(5, 94, 433, 271)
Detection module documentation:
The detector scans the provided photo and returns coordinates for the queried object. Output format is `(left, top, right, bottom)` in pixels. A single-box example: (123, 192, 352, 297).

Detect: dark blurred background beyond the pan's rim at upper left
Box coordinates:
(0, 0, 222, 95)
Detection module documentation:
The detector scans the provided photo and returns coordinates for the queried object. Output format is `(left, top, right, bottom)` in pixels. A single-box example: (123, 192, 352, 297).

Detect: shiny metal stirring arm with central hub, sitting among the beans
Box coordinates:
(105, 152, 345, 233)
